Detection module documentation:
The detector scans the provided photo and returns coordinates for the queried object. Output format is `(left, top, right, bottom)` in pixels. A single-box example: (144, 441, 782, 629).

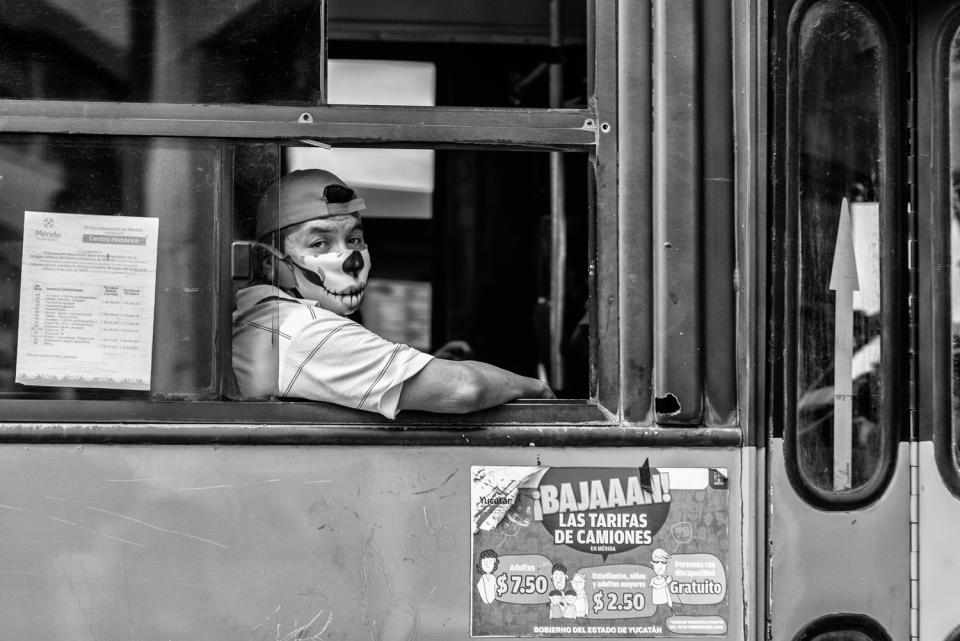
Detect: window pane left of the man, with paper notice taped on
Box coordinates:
(0, 136, 222, 399)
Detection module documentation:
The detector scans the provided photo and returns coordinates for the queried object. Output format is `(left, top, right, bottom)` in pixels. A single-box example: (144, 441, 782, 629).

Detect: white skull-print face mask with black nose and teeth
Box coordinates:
(284, 249, 370, 315)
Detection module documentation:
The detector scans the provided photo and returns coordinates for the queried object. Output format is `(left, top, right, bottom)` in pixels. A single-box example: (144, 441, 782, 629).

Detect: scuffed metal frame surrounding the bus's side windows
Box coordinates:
(0, 0, 636, 430)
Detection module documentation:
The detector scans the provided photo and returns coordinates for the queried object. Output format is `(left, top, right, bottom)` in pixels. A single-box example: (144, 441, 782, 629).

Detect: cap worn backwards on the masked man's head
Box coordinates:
(257, 169, 366, 238)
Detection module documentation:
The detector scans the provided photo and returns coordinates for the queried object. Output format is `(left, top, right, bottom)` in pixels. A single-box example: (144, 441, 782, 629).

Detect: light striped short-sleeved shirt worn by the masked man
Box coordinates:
(233, 285, 433, 418)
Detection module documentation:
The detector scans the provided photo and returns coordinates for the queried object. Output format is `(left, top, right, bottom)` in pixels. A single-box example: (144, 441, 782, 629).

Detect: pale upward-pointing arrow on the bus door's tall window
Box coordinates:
(830, 198, 860, 490)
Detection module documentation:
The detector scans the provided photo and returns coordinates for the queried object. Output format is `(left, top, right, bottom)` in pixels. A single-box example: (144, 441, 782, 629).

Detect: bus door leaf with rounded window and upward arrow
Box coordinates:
(766, 0, 912, 641)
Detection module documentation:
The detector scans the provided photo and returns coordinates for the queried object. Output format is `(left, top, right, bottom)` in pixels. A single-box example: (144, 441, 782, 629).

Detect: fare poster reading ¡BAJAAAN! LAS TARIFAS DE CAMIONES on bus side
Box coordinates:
(470, 461, 729, 638)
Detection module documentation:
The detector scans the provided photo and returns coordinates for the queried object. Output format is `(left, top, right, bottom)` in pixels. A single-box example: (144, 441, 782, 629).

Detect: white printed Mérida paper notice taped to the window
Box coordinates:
(16, 211, 158, 390)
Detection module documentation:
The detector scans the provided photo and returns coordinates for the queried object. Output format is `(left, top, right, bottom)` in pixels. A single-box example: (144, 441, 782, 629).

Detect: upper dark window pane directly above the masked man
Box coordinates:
(328, 0, 587, 107)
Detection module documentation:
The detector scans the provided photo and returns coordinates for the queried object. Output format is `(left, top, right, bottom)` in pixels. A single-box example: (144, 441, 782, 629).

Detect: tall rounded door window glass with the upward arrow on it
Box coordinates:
(792, 0, 892, 491)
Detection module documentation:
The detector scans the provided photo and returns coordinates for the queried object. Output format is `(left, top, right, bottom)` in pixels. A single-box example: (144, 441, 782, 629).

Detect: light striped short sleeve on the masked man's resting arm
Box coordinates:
(280, 313, 433, 419)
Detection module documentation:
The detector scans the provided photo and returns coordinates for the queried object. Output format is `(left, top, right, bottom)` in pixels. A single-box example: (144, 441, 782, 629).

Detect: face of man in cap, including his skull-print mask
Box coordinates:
(282, 214, 370, 315)
